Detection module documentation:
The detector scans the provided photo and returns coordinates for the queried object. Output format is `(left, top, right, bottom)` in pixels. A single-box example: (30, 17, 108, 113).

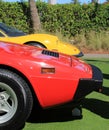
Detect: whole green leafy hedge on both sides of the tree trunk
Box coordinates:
(0, 1, 109, 36)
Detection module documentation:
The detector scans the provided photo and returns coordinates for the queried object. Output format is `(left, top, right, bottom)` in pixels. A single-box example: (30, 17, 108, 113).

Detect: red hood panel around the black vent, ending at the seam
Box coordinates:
(0, 42, 71, 66)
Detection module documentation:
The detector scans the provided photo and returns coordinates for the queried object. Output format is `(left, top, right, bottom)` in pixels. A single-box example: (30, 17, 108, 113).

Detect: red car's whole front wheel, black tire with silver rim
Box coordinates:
(0, 69, 33, 130)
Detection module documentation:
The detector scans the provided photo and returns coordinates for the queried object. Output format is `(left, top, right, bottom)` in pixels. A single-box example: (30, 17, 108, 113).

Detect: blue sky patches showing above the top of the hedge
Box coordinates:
(4, 0, 106, 4)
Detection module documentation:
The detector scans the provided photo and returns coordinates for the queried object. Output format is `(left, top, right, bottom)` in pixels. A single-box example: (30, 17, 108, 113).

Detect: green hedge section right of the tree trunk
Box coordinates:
(37, 3, 109, 36)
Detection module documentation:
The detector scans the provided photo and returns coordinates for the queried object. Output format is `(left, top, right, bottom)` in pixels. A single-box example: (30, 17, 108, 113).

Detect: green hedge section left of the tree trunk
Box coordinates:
(0, 2, 29, 32)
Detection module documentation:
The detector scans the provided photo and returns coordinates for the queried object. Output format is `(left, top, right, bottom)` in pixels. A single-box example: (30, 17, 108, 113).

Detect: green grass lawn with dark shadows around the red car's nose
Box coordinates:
(23, 58, 109, 130)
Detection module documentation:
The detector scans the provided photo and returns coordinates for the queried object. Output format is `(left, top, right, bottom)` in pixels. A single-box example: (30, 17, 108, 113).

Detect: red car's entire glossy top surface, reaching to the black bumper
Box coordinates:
(0, 42, 91, 74)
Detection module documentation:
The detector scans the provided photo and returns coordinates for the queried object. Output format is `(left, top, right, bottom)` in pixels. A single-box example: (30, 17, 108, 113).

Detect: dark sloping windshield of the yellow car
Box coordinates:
(0, 23, 25, 36)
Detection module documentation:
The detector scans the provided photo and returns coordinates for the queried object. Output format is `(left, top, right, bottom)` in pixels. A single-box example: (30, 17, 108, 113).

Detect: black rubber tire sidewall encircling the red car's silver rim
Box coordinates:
(0, 70, 32, 130)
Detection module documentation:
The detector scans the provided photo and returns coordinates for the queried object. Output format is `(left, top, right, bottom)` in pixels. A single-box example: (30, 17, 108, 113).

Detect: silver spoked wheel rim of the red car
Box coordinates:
(0, 82, 18, 124)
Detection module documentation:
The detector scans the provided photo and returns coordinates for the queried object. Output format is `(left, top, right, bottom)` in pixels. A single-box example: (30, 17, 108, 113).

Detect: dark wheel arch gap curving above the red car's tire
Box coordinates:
(0, 64, 41, 107)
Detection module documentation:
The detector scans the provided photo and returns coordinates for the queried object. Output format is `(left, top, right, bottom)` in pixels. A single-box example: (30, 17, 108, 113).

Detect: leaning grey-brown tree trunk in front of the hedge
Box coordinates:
(29, 0, 41, 33)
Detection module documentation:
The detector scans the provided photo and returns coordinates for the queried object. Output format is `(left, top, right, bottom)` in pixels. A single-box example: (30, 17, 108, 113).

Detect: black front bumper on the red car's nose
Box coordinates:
(73, 65, 103, 100)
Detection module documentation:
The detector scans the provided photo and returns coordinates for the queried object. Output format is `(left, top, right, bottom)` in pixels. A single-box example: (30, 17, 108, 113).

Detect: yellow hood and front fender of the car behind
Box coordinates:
(0, 34, 81, 56)
